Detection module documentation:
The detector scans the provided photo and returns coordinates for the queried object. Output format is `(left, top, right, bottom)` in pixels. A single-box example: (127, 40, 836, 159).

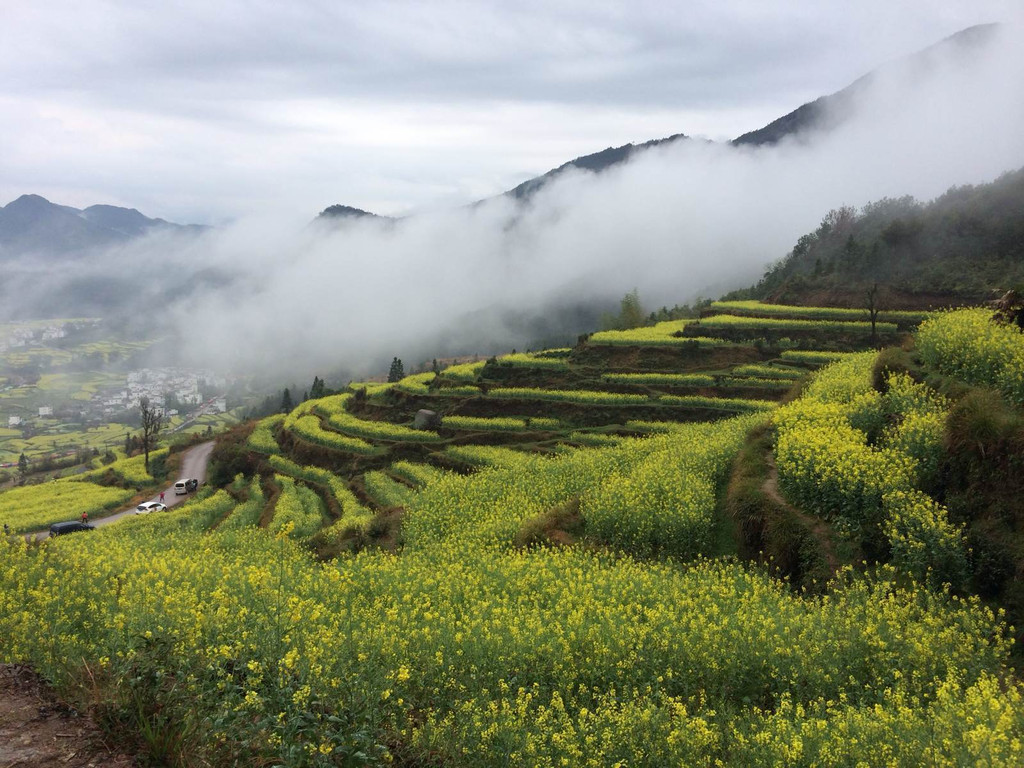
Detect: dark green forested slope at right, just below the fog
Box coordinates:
(727, 169, 1024, 308)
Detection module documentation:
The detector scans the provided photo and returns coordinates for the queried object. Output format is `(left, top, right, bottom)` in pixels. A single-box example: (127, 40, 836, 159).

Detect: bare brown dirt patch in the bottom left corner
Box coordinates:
(0, 665, 138, 768)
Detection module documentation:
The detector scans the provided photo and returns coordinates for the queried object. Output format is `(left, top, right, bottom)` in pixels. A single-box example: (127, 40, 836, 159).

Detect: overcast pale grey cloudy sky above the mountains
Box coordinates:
(0, 0, 1022, 224)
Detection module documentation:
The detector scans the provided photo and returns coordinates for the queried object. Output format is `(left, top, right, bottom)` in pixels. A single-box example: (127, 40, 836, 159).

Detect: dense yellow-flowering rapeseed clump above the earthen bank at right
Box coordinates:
(773, 352, 967, 585)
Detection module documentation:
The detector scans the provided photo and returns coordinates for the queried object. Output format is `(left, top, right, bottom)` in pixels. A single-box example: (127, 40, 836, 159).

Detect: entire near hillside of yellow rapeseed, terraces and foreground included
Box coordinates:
(0, 306, 1024, 768)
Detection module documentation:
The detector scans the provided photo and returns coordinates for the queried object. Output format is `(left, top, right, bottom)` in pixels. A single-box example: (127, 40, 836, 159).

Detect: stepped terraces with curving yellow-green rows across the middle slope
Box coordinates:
(4, 302, 920, 547)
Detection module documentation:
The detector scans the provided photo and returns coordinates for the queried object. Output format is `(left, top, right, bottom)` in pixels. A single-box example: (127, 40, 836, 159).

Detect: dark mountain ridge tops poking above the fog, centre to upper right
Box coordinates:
(319, 24, 999, 219)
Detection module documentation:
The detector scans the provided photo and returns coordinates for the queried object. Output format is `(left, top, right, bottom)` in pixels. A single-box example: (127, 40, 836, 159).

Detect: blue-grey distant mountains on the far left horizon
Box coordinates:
(0, 195, 206, 260)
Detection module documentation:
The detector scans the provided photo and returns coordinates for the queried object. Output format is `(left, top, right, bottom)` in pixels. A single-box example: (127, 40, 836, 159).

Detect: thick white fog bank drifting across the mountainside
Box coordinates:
(0, 24, 1024, 380)
